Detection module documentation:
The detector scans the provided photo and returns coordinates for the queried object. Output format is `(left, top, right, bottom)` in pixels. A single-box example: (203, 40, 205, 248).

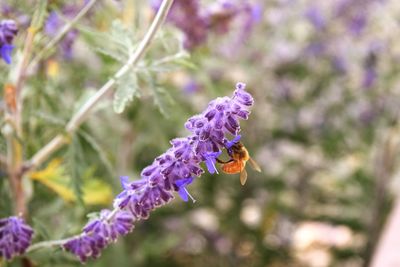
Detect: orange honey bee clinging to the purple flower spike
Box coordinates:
(216, 142, 261, 185)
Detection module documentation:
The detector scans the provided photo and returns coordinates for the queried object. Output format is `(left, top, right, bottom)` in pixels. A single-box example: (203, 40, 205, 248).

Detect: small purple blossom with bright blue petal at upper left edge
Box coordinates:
(0, 19, 18, 64)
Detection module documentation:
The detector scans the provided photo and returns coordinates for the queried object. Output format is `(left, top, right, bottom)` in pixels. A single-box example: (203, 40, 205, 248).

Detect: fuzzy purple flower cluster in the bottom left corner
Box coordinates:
(0, 216, 33, 260)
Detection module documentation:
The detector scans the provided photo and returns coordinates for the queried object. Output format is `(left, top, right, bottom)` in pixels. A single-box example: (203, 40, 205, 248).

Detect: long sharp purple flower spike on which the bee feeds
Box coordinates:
(63, 83, 254, 262)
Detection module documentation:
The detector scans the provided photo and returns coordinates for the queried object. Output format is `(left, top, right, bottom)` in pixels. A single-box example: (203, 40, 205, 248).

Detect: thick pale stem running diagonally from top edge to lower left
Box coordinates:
(26, 0, 173, 170)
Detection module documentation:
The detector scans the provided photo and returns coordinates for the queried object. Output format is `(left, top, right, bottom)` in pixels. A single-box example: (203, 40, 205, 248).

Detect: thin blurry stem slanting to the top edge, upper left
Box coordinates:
(28, 0, 97, 73)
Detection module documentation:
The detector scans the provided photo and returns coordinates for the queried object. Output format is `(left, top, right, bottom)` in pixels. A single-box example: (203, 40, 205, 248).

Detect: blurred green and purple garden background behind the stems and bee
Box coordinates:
(0, 0, 400, 267)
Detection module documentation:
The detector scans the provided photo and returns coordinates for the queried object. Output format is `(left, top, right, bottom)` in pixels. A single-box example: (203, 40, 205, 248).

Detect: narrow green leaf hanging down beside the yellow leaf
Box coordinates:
(67, 134, 84, 205)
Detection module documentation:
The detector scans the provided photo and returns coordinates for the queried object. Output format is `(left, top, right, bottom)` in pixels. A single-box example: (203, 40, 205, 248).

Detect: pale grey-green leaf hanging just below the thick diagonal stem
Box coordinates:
(113, 73, 140, 113)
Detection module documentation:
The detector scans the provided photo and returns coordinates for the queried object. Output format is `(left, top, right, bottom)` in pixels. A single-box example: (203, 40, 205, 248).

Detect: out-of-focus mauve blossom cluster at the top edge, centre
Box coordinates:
(151, 0, 261, 50)
